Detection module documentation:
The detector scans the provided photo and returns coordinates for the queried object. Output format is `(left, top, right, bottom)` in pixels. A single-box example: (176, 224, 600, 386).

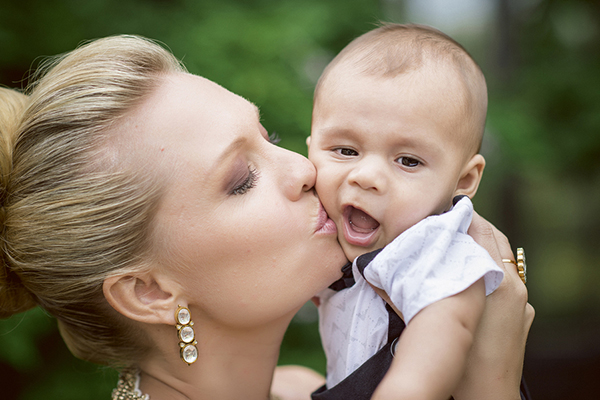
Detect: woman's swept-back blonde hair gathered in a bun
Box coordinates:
(0, 35, 184, 364)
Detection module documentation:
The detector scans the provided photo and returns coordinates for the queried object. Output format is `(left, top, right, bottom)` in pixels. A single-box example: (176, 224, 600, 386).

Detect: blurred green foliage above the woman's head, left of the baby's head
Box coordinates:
(0, 0, 382, 155)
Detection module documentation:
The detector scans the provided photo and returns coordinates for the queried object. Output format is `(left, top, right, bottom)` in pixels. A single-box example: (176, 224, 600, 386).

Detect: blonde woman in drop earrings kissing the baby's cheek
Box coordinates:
(0, 36, 533, 400)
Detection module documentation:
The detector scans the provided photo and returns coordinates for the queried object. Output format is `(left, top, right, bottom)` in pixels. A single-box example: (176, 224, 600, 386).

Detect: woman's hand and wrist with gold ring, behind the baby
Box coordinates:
(454, 213, 535, 400)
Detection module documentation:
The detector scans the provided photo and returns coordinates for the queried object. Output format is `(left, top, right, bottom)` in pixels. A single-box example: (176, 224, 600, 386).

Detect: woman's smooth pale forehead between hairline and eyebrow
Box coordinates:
(106, 73, 259, 188)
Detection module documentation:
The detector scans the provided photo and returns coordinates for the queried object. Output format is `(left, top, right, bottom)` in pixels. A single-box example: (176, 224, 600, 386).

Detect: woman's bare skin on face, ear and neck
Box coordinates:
(104, 73, 346, 400)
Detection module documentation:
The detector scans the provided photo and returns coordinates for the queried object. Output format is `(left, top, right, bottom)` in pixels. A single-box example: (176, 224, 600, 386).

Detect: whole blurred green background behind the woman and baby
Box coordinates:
(0, 0, 600, 400)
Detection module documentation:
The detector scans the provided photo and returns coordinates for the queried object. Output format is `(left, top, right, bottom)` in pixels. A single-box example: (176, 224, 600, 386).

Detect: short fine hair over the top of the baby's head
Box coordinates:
(314, 23, 487, 153)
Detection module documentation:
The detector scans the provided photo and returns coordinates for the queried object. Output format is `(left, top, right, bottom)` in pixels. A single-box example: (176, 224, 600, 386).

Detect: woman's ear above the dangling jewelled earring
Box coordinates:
(102, 273, 178, 325)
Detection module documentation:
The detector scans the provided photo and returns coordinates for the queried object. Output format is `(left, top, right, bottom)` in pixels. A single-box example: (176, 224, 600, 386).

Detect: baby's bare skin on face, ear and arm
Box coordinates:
(307, 64, 516, 400)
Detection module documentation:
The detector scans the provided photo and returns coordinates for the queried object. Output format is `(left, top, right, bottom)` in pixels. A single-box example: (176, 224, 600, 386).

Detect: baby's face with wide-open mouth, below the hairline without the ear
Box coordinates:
(309, 67, 474, 260)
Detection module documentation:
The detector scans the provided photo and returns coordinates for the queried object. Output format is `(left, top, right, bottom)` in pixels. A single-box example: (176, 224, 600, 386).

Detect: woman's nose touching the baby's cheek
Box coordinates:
(278, 149, 317, 201)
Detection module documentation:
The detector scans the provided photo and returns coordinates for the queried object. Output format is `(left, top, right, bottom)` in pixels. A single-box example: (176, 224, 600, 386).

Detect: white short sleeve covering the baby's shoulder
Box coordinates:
(364, 197, 504, 324)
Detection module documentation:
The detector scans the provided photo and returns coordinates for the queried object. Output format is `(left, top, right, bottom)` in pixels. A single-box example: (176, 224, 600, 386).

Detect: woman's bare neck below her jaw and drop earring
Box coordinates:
(140, 325, 285, 400)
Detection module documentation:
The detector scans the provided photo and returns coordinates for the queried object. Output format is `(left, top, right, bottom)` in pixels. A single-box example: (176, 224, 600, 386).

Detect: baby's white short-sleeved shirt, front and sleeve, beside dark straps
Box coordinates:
(319, 198, 503, 388)
